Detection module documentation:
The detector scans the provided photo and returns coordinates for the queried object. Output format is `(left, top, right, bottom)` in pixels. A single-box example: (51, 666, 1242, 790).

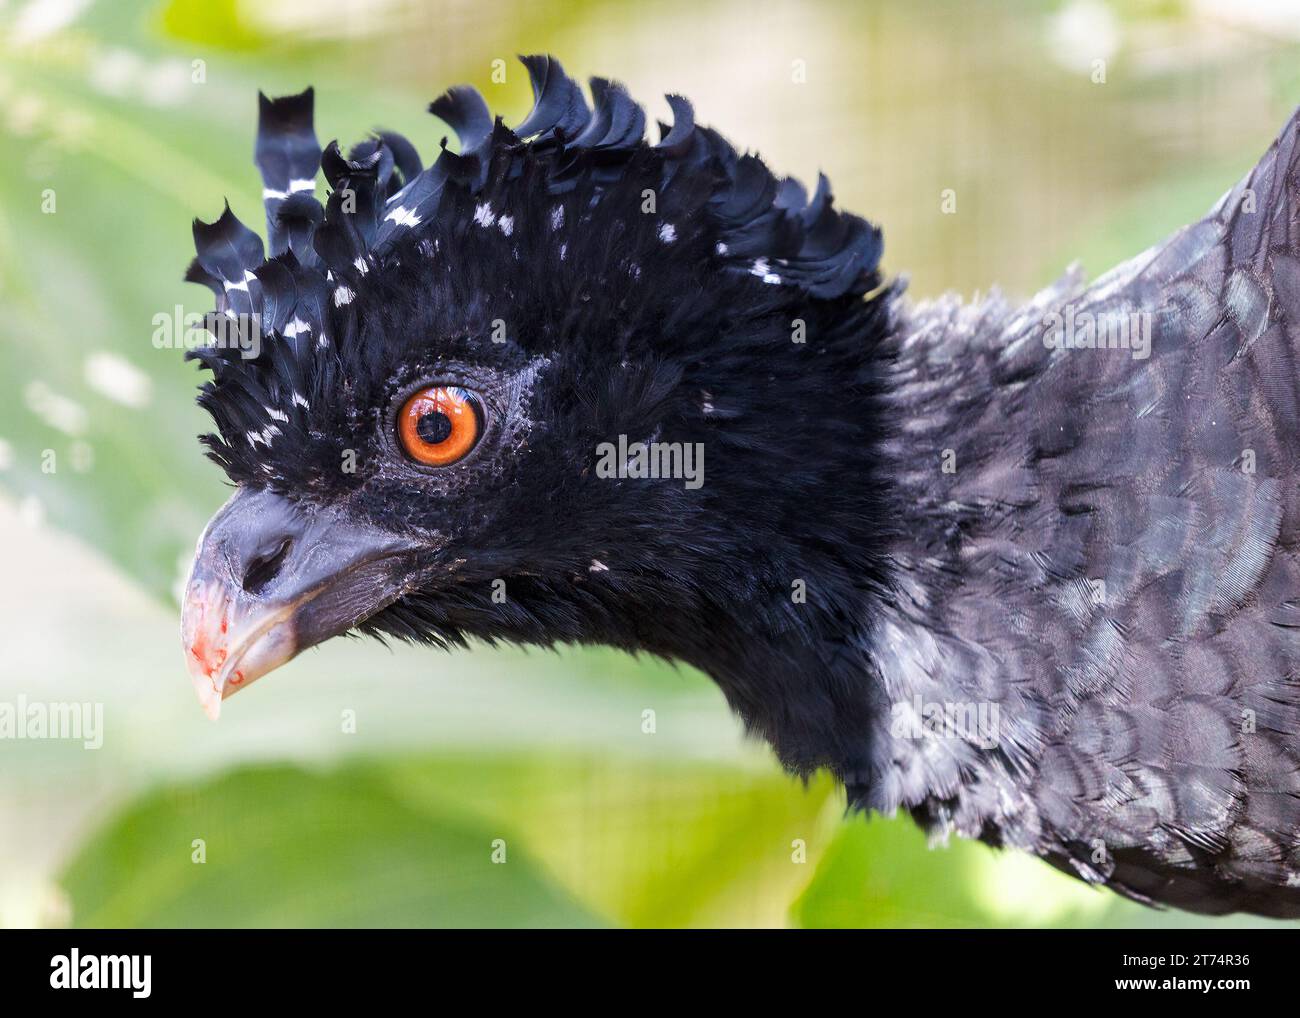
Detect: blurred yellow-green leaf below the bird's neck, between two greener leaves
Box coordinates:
(371, 751, 842, 927)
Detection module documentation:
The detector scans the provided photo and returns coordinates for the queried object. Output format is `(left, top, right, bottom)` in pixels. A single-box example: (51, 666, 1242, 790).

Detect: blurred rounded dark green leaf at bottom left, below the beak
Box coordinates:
(62, 767, 599, 927)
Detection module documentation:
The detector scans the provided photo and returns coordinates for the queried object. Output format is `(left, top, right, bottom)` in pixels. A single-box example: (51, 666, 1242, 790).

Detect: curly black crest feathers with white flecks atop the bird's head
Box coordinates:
(186, 56, 881, 482)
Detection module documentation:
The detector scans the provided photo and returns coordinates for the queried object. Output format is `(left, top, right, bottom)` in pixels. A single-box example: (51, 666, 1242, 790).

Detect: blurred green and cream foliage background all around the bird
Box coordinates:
(0, 0, 1300, 927)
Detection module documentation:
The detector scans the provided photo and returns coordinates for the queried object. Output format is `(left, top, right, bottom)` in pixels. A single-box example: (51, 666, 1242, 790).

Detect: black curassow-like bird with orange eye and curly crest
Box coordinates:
(183, 57, 1300, 917)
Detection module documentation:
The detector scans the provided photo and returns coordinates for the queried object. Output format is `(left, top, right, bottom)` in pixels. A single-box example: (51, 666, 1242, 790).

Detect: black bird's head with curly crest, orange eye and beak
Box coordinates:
(182, 57, 889, 780)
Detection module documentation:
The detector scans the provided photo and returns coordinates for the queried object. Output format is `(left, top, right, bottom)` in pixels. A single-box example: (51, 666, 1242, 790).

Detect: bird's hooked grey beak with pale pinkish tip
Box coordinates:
(181, 488, 407, 719)
